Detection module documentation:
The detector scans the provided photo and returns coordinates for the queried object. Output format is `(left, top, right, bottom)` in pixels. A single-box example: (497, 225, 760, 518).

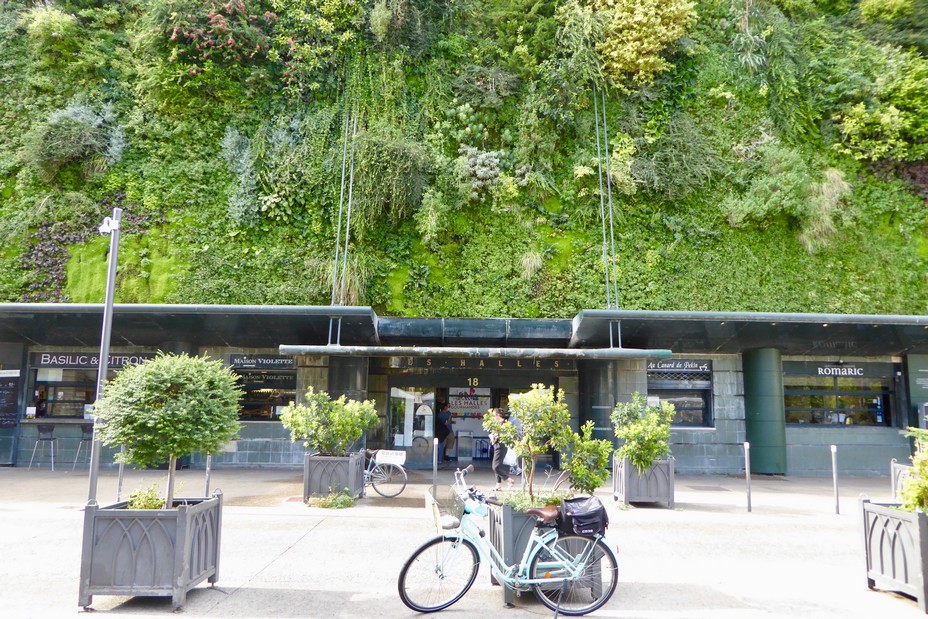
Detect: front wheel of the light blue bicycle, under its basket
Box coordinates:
(398, 536, 480, 613)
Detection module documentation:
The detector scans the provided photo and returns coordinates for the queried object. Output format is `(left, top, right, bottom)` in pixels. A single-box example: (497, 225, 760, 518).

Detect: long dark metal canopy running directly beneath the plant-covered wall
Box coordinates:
(0, 303, 928, 356)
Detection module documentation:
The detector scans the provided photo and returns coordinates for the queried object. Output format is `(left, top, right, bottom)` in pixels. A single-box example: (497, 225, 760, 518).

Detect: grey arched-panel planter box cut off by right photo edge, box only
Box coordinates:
(861, 499, 928, 612)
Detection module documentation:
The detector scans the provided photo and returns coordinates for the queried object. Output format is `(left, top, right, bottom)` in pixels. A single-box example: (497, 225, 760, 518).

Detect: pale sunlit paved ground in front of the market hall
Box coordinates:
(0, 468, 924, 619)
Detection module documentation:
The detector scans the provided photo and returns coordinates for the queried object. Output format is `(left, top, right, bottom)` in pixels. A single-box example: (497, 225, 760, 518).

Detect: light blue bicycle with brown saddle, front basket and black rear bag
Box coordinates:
(398, 466, 619, 616)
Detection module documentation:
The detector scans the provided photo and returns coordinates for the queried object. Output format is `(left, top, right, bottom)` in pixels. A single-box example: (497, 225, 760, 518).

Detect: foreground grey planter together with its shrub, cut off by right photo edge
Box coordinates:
(861, 428, 928, 612)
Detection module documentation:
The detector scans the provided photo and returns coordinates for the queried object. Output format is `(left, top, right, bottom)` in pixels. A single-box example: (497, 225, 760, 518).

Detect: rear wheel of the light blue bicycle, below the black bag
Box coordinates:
(529, 535, 619, 616)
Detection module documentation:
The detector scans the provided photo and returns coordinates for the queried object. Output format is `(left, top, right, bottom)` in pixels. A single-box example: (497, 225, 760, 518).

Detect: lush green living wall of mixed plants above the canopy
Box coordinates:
(0, 0, 928, 317)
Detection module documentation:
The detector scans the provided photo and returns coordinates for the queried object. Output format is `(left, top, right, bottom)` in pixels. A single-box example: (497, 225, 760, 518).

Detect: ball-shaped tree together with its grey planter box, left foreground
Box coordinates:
(78, 353, 242, 609)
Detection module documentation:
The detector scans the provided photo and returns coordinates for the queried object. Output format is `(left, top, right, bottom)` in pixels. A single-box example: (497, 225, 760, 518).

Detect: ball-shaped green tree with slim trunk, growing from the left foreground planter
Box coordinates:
(94, 353, 243, 509)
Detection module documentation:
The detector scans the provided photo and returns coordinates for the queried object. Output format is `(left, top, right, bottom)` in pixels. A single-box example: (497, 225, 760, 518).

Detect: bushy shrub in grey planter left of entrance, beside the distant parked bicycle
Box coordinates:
(280, 387, 380, 501)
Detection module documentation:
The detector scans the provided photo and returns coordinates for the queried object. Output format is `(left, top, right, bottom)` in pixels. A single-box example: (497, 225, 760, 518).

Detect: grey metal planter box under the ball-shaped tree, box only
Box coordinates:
(78, 491, 222, 609)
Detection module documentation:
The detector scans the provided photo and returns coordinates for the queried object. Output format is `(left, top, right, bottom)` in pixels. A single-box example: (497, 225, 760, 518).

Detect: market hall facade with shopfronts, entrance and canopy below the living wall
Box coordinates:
(0, 304, 928, 476)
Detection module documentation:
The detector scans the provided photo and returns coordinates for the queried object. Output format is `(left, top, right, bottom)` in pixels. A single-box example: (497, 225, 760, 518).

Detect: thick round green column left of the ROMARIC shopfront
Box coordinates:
(742, 348, 786, 475)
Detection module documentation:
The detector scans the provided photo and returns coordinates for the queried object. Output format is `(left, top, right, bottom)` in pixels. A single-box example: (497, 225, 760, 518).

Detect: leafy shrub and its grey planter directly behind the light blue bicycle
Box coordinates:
(483, 384, 612, 603)
